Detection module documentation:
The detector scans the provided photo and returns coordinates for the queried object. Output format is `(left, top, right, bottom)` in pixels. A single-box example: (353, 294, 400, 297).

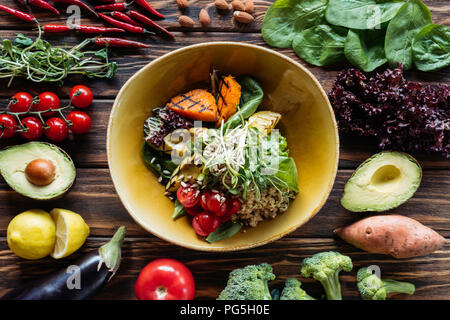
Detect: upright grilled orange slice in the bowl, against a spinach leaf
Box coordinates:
(216, 76, 241, 127)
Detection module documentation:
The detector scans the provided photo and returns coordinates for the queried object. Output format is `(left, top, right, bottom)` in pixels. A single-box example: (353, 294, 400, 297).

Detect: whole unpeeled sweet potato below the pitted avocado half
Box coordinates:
(334, 215, 445, 258)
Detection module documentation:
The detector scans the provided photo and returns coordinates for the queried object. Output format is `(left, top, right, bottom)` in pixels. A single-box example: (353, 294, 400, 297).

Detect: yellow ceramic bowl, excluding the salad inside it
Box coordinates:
(107, 42, 339, 251)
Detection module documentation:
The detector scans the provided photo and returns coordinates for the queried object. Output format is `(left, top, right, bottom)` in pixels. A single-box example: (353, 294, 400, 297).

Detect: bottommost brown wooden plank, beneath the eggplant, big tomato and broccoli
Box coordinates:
(0, 236, 450, 299)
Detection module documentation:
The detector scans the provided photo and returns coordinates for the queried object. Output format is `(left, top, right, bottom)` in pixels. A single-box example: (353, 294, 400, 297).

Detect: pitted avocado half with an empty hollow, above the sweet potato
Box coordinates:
(341, 151, 422, 212)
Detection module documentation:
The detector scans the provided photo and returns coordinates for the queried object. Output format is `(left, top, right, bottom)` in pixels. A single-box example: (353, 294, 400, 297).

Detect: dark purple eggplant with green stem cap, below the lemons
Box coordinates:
(2, 226, 126, 300)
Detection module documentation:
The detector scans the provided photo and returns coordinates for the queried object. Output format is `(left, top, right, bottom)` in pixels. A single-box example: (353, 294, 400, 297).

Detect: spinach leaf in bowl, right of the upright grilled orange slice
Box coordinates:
(224, 76, 264, 129)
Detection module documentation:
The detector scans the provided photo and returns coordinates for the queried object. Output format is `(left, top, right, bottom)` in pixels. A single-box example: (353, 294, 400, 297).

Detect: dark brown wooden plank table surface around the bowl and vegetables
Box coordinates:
(0, 0, 450, 299)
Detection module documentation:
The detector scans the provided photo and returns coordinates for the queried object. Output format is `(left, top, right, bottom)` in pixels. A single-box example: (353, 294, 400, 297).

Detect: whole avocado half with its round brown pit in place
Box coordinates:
(0, 142, 76, 200)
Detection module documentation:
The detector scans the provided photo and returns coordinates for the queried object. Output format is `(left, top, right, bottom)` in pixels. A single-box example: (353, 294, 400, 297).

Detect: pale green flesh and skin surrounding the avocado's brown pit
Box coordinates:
(0, 141, 76, 200)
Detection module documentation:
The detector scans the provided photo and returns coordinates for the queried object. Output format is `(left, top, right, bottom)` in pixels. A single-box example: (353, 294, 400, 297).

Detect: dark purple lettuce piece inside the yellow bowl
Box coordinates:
(144, 108, 194, 151)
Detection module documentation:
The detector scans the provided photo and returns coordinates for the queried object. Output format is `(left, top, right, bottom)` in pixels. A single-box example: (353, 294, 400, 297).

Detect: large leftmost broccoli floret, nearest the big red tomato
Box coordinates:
(217, 263, 275, 300)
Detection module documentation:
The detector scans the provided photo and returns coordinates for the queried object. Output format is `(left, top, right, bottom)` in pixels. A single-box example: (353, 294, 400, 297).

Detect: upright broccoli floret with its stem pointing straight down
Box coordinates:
(301, 251, 353, 300)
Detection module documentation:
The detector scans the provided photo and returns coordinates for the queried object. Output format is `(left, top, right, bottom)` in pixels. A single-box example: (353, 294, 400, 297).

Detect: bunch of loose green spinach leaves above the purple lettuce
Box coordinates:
(261, 0, 450, 72)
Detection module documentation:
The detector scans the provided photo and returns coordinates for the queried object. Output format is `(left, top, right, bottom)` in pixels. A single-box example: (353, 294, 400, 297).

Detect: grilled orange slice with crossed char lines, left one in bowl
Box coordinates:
(167, 89, 218, 122)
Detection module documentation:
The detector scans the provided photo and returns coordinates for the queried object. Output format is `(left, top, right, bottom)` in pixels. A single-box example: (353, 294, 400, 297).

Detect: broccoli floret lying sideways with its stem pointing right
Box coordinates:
(357, 268, 416, 300)
